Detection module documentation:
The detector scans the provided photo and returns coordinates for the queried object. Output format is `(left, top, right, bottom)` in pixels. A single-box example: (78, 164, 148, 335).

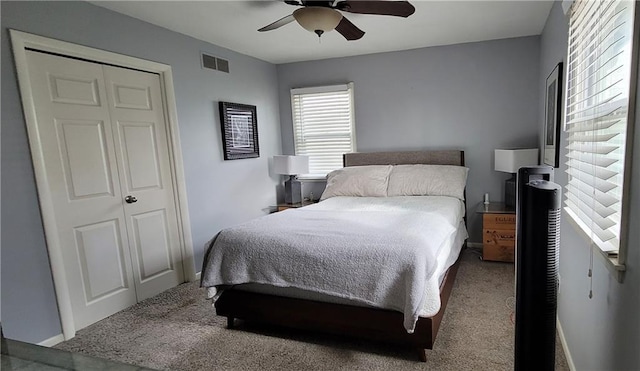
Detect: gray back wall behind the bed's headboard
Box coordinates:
(278, 36, 540, 242)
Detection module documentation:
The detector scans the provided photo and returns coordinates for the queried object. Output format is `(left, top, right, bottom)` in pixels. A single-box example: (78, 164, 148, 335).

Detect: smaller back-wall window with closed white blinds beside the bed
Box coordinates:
(291, 83, 356, 178)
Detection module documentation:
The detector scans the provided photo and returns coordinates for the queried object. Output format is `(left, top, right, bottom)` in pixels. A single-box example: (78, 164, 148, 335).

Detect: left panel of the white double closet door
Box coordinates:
(27, 51, 136, 329)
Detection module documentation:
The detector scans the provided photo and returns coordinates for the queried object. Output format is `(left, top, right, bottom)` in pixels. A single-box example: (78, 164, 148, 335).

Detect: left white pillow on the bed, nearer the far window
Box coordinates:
(320, 165, 391, 200)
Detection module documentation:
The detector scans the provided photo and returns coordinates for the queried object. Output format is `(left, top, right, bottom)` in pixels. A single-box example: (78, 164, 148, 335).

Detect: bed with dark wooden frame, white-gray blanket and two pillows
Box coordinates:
(201, 150, 468, 361)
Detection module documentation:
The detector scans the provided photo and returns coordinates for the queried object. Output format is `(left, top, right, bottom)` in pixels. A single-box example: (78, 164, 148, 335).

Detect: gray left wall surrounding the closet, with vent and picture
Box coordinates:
(1, 1, 281, 342)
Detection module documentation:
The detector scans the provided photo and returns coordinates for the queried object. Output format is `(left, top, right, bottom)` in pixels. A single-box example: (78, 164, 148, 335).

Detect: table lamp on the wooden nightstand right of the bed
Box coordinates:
(495, 148, 538, 209)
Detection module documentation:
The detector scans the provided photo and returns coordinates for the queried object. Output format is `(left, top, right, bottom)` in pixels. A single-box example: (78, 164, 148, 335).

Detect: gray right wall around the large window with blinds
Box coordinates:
(539, 2, 640, 370)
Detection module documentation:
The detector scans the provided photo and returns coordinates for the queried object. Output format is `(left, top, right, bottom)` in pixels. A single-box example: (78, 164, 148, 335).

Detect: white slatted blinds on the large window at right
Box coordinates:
(565, 0, 634, 254)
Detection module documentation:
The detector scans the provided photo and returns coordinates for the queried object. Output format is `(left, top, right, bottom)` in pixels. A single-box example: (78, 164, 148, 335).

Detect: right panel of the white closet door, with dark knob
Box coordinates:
(104, 66, 183, 300)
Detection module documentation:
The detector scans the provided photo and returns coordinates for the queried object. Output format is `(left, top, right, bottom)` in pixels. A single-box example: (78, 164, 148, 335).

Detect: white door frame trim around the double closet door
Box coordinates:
(9, 29, 197, 340)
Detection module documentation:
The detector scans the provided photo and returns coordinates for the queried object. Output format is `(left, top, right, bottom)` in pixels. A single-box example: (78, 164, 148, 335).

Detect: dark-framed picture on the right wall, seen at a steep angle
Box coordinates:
(542, 62, 562, 168)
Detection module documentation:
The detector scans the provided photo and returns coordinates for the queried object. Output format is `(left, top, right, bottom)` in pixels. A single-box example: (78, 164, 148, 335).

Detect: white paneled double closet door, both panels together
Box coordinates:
(27, 51, 183, 329)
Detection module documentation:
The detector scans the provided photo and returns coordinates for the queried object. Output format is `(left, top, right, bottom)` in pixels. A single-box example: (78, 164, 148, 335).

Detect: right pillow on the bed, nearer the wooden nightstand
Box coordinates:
(387, 165, 469, 200)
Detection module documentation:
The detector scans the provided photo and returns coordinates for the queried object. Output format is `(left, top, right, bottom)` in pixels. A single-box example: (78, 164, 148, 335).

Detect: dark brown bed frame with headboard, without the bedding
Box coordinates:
(215, 150, 464, 362)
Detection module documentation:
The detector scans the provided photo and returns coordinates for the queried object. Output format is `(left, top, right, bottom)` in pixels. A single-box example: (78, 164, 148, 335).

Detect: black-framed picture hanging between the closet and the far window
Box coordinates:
(219, 102, 260, 160)
